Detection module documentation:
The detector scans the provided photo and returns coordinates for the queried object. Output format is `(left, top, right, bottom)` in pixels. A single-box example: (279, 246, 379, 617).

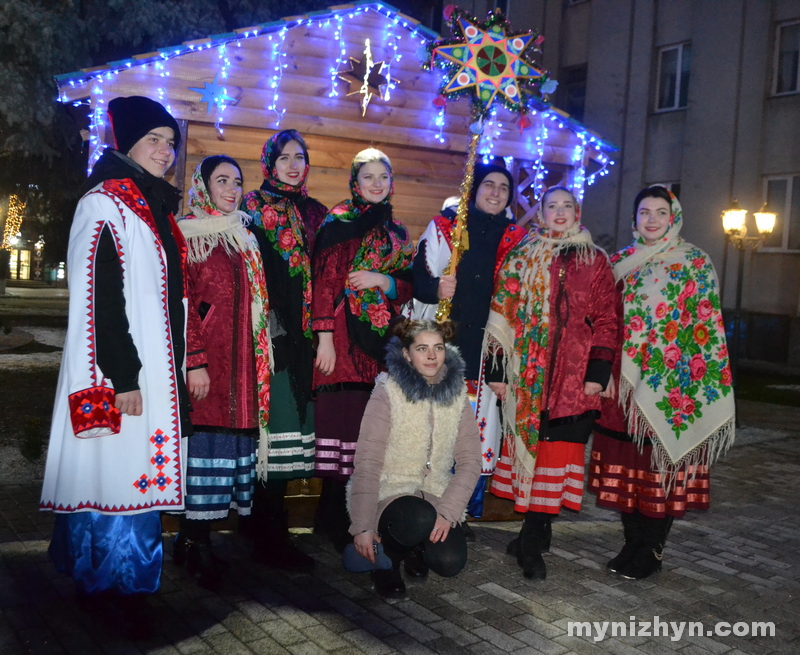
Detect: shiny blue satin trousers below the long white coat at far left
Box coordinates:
(49, 511, 163, 595)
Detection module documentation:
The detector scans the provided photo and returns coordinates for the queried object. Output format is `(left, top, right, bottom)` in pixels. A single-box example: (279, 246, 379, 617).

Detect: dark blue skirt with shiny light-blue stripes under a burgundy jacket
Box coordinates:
(186, 432, 257, 521)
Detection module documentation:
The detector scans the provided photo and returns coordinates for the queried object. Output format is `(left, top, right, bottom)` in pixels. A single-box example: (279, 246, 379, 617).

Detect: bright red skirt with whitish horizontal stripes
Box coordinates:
(490, 439, 585, 514)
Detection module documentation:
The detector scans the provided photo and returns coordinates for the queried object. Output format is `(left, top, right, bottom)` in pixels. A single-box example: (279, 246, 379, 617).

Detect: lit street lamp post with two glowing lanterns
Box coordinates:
(722, 198, 777, 386)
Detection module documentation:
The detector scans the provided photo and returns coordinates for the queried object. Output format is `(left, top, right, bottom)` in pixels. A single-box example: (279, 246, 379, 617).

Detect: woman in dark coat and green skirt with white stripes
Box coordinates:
(244, 130, 328, 569)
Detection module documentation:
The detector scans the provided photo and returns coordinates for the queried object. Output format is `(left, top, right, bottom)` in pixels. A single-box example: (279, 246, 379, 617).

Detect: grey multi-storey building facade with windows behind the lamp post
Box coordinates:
(473, 0, 800, 364)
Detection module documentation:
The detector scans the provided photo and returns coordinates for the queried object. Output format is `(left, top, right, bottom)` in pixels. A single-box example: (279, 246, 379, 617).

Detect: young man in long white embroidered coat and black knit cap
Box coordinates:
(40, 96, 191, 616)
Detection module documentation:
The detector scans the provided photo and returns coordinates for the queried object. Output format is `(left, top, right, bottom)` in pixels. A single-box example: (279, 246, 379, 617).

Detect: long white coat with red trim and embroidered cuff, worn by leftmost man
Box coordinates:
(40, 180, 186, 514)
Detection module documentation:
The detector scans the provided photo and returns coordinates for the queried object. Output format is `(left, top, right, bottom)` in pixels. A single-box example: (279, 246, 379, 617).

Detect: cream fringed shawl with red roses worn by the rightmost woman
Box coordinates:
(611, 184, 734, 491)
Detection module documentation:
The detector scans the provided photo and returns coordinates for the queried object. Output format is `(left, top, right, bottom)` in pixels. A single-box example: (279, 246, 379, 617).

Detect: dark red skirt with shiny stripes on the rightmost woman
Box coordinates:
(589, 432, 711, 518)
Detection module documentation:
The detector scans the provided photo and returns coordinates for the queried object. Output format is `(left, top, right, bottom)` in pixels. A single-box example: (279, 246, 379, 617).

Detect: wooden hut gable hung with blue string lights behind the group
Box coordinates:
(56, 2, 616, 238)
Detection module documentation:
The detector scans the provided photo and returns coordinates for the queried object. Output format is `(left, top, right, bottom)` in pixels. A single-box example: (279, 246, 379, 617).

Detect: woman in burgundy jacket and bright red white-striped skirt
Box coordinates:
(484, 187, 619, 580)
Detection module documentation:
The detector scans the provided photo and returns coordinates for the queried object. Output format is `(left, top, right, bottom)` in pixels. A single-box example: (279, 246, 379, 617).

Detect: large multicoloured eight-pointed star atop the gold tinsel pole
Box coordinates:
(423, 5, 552, 122)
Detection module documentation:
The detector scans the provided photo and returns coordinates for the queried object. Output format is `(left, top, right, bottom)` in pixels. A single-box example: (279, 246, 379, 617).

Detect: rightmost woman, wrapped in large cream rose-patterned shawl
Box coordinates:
(589, 186, 734, 579)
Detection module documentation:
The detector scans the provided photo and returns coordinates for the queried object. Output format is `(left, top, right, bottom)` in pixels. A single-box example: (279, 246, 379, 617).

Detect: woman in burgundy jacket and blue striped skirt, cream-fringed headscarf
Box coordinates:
(179, 155, 270, 586)
